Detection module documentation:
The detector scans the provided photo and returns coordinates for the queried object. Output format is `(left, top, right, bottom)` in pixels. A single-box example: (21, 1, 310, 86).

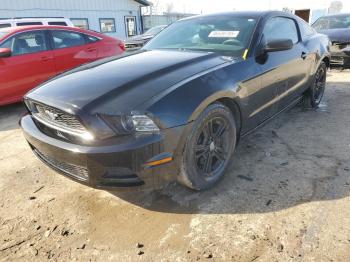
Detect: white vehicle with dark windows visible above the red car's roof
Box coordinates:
(0, 17, 74, 28)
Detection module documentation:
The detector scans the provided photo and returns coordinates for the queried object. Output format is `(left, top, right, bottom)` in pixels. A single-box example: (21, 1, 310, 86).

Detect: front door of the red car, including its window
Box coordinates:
(0, 30, 56, 102)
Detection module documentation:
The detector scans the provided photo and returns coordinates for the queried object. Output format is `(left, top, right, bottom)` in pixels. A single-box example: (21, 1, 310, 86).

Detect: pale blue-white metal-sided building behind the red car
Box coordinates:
(0, 0, 149, 39)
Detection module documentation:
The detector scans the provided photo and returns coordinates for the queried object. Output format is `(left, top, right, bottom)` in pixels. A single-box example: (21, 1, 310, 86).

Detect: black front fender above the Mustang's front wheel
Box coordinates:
(147, 64, 238, 128)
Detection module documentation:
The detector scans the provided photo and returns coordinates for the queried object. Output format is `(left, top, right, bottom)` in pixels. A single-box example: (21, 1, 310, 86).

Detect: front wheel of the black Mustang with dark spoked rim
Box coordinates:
(179, 103, 236, 191)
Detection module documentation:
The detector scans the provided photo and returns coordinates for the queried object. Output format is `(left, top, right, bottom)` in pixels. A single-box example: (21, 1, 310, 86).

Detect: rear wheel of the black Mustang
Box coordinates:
(303, 62, 327, 108)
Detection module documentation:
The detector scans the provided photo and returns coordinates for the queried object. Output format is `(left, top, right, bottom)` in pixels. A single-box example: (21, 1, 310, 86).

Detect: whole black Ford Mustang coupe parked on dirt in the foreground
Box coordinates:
(21, 12, 329, 190)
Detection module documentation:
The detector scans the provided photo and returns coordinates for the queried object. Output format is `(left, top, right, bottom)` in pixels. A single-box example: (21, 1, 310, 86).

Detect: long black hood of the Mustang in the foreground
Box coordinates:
(26, 50, 227, 114)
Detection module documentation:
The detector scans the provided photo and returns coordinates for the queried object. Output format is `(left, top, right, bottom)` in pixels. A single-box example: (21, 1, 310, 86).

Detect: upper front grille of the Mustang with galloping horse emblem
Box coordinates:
(33, 104, 86, 133)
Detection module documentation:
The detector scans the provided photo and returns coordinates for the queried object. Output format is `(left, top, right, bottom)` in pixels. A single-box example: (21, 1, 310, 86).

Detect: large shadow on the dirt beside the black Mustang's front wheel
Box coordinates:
(110, 101, 350, 214)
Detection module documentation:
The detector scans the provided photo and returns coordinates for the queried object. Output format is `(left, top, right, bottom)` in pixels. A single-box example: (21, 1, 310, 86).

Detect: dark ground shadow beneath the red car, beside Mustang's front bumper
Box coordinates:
(0, 103, 26, 132)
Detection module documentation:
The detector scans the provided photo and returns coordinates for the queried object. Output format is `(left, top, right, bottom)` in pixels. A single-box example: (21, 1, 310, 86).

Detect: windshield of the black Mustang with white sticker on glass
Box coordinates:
(144, 16, 256, 57)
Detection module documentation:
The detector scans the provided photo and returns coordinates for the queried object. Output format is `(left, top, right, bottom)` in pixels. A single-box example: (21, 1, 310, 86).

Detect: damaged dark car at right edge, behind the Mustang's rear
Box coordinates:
(312, 14, 350, 68)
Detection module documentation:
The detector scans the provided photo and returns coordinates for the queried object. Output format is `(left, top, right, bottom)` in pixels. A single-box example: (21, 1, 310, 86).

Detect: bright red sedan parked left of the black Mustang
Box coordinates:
(0, 26, 125, 105)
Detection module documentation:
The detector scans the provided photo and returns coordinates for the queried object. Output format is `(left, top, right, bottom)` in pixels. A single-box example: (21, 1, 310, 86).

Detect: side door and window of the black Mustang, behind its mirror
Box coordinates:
(261, 16, 309, 112)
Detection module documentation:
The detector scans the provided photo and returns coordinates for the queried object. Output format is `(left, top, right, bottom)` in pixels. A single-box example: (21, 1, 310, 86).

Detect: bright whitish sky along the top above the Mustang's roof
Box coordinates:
(151, 0, 350, 14)
